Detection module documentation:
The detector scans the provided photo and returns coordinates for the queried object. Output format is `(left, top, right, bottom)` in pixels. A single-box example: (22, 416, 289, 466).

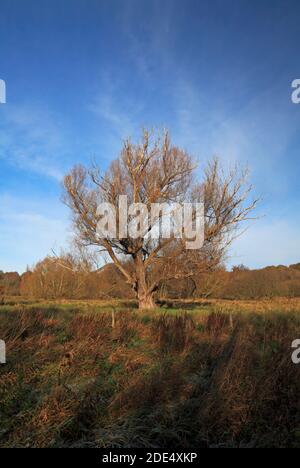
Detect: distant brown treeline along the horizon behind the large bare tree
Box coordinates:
(0, 257, 300, 300)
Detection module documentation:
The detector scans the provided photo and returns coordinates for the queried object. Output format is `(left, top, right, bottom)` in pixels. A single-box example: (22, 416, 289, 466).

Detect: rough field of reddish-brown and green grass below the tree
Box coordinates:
(0, 298, 300, 448)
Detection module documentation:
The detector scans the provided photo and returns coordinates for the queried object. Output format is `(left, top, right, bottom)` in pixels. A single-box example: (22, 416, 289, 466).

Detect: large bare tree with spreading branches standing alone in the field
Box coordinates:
(63, 130, 257, 309)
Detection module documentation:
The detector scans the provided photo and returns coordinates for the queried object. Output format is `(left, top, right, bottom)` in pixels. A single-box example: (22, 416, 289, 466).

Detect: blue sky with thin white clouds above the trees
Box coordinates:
(0, 0, 300, 272)
